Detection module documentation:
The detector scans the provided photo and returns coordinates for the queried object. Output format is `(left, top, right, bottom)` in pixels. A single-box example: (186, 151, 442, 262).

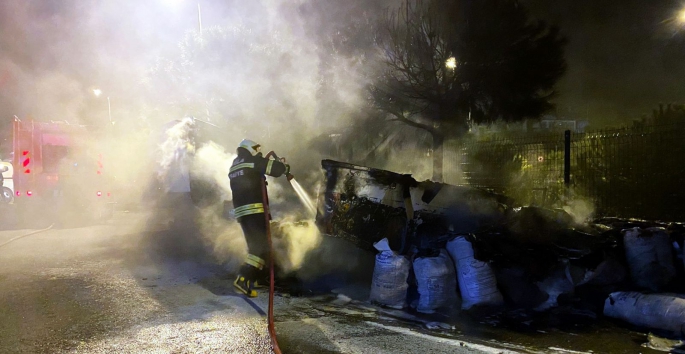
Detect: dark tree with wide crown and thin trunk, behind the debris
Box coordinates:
(369, 0, 566, 181)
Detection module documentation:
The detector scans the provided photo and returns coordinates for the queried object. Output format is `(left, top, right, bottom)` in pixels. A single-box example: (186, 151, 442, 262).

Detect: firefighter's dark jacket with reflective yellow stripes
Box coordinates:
(228, 148, 287, 220)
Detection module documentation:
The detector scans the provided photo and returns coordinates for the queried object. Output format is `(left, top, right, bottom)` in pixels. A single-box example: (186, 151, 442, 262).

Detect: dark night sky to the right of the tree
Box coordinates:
(522, 0, 685, 127)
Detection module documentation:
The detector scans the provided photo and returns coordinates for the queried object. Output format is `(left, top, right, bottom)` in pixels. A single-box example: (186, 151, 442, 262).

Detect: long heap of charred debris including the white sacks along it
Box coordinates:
(316, 160, 685, 336)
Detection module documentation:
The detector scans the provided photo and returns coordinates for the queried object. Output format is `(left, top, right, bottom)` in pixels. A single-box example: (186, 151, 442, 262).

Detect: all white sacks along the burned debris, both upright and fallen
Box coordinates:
(370, 227, 685, 335)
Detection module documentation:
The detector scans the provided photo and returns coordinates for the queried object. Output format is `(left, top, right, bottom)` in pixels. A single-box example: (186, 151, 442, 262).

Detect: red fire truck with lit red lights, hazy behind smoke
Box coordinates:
(12, 117, 114, 221)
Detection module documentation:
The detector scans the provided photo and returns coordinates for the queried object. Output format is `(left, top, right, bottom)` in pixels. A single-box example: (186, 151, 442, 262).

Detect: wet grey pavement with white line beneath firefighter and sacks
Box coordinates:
(0, 209, 672, 353)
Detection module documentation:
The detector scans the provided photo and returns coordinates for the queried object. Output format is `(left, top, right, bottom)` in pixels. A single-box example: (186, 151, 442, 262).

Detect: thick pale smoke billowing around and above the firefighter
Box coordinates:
(0, 0, 412, 280)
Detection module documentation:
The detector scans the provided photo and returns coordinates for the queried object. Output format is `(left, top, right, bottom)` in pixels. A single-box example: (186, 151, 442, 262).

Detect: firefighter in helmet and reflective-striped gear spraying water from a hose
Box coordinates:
(228, 139, 290, 297)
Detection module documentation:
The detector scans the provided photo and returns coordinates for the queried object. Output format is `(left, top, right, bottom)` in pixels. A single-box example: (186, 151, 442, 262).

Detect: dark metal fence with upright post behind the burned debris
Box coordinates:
(445, 119, 685, 221)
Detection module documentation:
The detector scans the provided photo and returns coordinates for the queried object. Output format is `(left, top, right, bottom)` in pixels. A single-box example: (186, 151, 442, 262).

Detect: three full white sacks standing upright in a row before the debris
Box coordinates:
(370, 236, 503, 313)
